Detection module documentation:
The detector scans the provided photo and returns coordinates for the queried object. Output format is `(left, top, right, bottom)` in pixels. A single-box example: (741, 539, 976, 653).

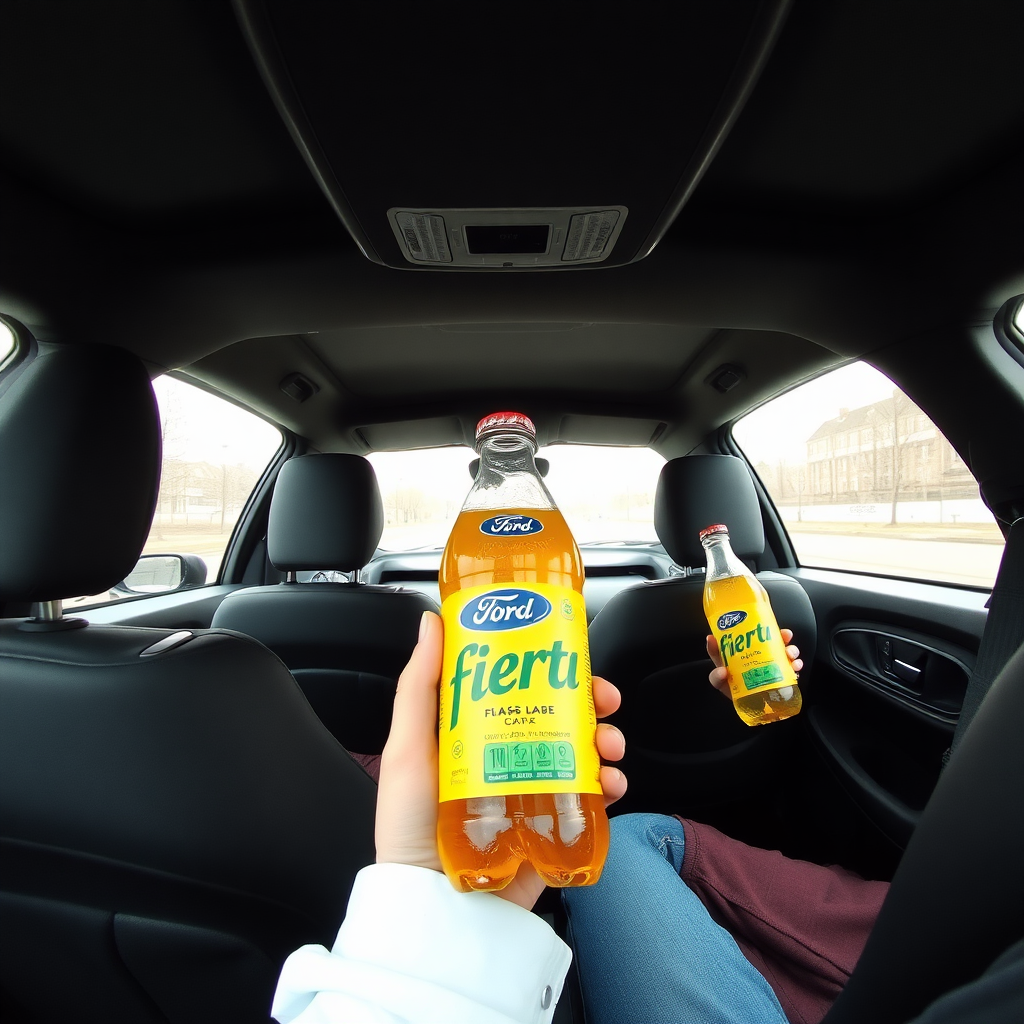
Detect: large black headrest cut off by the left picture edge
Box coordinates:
(0, 344, 160, 601)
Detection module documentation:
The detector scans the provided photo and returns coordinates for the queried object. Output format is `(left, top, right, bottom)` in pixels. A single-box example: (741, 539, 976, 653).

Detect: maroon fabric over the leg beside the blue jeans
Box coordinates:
(679, 818, 889, 1024)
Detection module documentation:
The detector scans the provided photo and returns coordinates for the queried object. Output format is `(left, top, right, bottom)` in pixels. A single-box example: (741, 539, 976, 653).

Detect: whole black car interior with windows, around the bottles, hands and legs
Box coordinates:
(0, 0, 1024, 1024)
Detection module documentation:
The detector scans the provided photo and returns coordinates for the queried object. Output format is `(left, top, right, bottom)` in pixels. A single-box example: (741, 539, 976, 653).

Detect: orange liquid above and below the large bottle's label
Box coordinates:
(437, 508, 608, 892)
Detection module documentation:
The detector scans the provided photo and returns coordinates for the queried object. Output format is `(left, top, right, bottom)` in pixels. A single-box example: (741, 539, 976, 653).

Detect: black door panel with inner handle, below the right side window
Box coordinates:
(785, 568, 987, 849)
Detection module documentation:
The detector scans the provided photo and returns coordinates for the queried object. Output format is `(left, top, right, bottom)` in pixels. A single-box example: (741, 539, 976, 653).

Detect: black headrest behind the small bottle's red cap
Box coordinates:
(654, 455, 765, 566)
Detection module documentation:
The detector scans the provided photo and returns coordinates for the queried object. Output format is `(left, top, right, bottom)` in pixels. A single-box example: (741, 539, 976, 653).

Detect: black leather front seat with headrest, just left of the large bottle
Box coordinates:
(213, 455, 438, 754)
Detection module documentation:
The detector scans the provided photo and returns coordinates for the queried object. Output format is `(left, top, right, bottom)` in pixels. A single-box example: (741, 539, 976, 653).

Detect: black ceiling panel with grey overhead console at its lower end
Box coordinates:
(233, 0, 790, 273)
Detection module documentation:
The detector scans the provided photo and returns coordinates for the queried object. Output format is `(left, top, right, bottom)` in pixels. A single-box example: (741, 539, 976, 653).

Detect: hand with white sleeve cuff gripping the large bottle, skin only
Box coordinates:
(376, 611, 626, 909)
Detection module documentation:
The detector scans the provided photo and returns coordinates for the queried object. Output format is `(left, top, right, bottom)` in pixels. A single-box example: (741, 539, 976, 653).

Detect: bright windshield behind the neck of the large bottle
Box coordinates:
(369, 444, 665, 551)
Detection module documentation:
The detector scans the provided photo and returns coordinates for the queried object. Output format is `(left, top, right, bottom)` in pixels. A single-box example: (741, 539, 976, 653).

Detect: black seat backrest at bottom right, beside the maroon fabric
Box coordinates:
(824, 647, 1024, 1024)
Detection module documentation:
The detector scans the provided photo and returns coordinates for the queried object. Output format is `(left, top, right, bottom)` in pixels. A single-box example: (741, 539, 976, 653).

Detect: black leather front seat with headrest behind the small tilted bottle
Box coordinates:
(590, 455, 817, 811)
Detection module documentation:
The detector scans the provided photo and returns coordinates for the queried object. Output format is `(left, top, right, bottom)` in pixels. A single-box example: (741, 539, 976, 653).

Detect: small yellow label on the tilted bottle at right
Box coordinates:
(710, 600, 797, 699)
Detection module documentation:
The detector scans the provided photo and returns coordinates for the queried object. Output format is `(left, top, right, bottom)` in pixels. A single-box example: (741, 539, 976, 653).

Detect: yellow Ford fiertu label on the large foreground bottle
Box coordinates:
(438, 583, 601, 801)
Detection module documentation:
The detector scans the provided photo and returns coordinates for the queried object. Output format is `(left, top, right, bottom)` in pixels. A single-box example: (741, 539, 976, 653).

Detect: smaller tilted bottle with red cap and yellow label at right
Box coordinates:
(700, 524, 803, 725)
